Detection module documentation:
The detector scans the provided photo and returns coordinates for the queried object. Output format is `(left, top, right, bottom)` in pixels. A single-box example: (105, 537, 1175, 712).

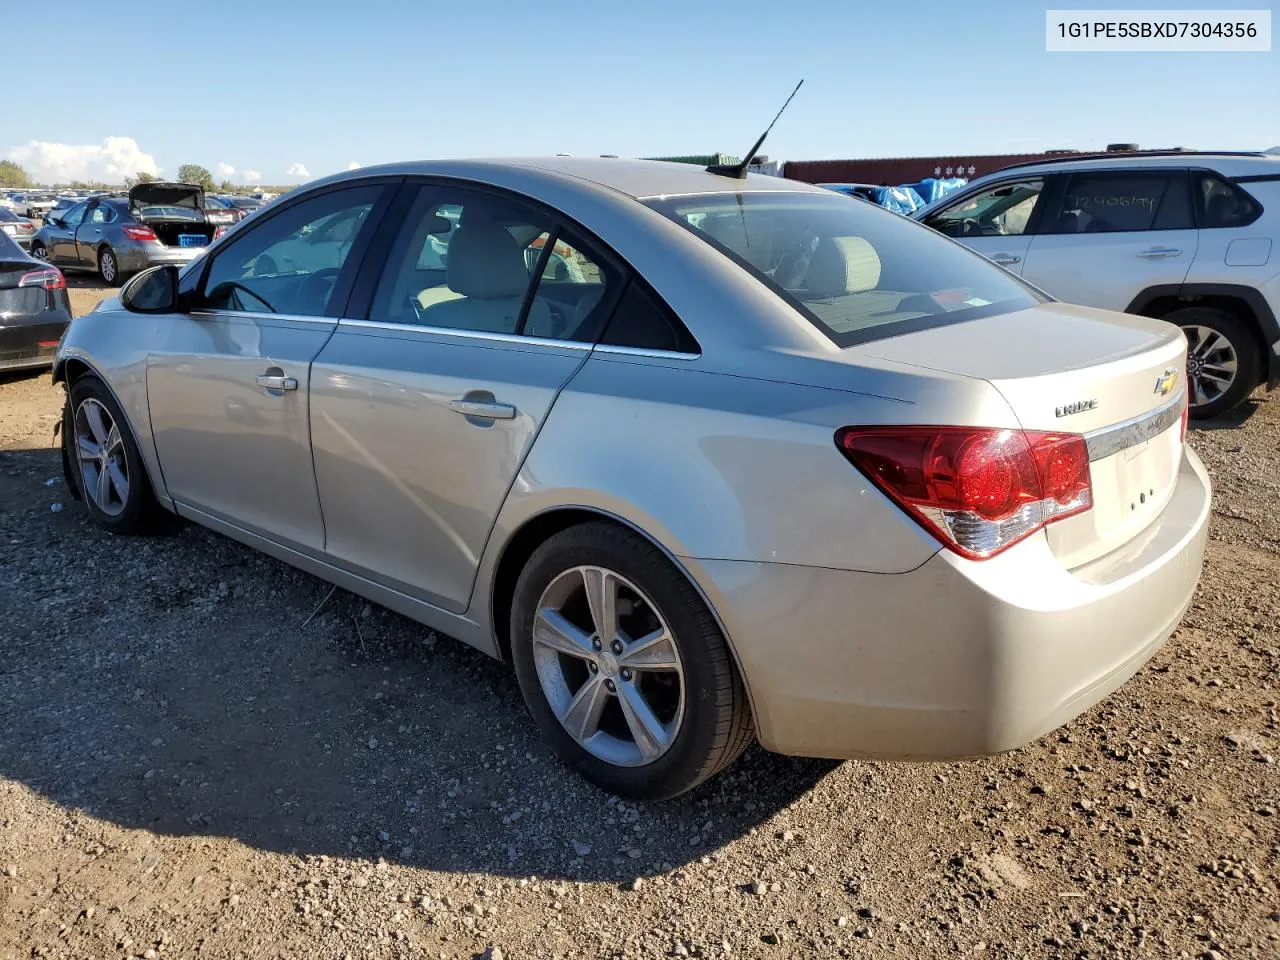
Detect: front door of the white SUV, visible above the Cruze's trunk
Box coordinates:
(924, 177, 1044, 274)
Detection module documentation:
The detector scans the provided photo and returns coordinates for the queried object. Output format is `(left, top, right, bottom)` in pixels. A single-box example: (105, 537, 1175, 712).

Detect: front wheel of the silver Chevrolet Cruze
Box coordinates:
(63, 375, 164, 534)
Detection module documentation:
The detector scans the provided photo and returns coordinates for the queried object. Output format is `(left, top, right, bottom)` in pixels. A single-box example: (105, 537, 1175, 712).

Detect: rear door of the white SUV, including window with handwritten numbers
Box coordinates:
(1023, 168, 1198, 310)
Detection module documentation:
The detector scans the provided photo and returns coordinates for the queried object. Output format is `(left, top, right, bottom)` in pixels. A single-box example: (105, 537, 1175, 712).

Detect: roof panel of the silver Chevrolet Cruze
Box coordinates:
(314, 156, 829, 200)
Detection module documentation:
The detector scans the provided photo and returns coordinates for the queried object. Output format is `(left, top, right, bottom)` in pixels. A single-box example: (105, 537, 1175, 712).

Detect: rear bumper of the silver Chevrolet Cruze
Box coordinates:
(698, 449, 1211, 759)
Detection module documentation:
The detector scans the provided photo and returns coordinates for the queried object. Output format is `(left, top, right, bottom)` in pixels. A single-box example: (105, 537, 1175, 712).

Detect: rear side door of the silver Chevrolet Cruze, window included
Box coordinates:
(311, 183, 622, 612)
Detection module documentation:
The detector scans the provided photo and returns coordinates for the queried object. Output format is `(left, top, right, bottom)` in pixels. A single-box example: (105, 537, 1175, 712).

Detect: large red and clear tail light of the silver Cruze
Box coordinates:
(836, 426, 1093, 559)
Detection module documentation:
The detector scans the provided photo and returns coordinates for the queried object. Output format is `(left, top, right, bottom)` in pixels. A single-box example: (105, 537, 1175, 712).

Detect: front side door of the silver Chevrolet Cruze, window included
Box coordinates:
(147, 182, 389, 553)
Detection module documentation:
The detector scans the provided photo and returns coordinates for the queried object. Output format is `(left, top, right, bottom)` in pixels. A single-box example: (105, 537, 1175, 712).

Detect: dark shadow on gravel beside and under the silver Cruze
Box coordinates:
(0, 451, 835, 882)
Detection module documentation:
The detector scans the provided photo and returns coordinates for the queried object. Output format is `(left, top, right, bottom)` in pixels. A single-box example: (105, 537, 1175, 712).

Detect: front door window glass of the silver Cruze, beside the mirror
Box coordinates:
(197, 186, 383, 316)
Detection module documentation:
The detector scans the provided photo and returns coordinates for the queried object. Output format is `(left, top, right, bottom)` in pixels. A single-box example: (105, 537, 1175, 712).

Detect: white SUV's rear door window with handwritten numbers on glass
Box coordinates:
(1038, 170, 1196, 233)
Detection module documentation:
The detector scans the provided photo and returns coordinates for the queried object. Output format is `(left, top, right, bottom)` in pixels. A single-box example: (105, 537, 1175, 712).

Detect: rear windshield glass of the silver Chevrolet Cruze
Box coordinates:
(645, 192, 1043, 347)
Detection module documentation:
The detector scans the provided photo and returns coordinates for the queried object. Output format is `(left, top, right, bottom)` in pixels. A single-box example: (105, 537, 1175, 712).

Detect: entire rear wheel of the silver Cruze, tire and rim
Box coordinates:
(511, 524, 754, 801)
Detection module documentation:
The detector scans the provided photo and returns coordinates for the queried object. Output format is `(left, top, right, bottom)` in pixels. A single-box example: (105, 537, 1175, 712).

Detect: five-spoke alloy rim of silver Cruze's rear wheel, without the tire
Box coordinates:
(532, 566, 685, 767)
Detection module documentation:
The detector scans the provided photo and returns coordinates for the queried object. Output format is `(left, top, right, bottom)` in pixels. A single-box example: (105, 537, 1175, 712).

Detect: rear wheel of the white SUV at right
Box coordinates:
(1164, 307, 1262, 420)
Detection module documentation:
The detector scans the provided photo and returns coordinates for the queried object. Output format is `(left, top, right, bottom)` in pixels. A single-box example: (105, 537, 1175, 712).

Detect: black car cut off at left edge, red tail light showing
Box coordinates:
(0, 233, 72, 371)
